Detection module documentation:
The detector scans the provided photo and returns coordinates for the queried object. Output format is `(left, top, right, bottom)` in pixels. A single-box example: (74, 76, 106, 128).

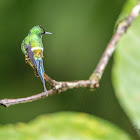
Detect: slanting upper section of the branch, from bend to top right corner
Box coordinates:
(90, 2, 140, 79)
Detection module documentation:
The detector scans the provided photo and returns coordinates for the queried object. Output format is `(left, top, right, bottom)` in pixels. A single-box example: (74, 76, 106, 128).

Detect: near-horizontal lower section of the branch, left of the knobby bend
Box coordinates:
(0, 80, 98, 107)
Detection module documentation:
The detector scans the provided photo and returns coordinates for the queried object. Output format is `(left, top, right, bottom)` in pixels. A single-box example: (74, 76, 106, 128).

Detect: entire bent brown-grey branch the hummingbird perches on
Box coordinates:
(0, 3, 140, 107)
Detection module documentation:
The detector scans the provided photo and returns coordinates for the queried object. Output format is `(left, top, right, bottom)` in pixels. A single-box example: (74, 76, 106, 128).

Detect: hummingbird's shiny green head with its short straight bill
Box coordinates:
(30, 25, 52, 35)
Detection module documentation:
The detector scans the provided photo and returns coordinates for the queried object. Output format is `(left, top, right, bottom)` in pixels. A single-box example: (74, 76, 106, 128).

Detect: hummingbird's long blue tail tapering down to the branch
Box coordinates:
(35, 59, 48, 96)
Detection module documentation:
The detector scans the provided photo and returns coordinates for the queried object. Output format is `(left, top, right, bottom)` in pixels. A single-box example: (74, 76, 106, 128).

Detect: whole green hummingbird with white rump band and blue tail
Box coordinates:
(21, 25, 52, 95)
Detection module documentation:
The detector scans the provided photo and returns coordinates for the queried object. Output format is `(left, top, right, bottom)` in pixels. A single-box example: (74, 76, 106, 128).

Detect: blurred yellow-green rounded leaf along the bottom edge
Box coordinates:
(0, 112, 130, 140)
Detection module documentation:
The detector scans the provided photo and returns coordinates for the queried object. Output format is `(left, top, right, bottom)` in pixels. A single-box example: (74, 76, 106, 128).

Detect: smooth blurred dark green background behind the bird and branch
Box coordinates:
(0, 0, 131, 135)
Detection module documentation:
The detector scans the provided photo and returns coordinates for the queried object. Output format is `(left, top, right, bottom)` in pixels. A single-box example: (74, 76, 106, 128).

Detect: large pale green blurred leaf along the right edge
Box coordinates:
(113, 2, 140, 135)
